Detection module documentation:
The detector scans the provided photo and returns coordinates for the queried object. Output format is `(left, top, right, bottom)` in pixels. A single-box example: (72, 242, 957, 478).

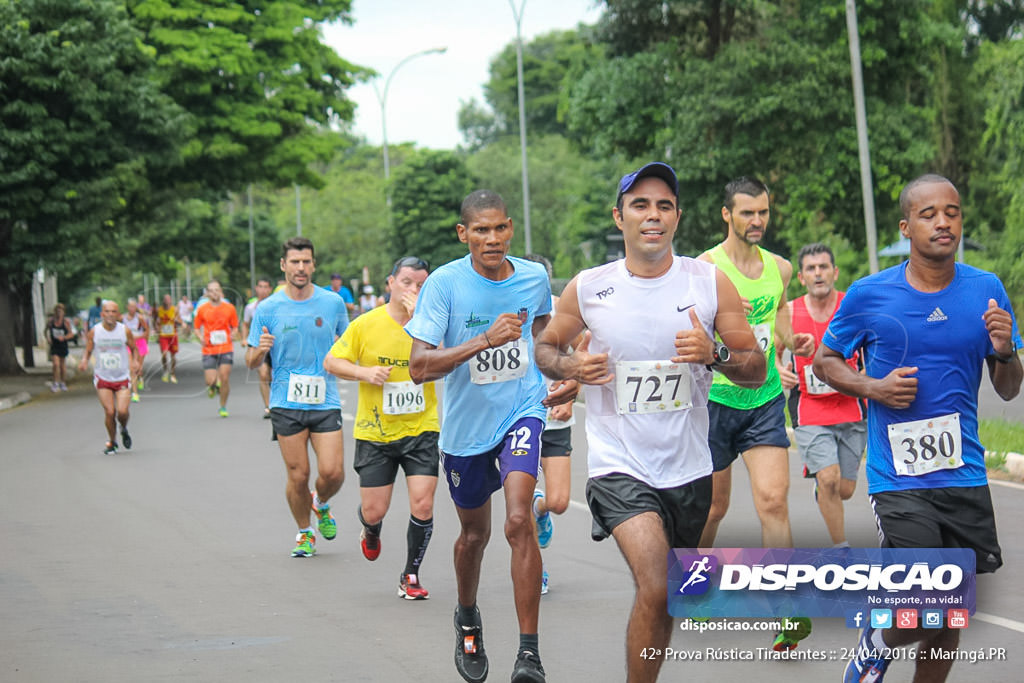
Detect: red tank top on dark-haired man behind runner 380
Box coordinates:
(793, 292, 863, 426)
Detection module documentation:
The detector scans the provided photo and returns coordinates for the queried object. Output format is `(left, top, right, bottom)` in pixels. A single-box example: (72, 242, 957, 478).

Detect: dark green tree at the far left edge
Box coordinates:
(0, 0, 183, 374)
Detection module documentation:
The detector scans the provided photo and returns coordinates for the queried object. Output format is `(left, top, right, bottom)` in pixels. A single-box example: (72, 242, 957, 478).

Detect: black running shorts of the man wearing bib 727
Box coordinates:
(587, 474, 711, 548)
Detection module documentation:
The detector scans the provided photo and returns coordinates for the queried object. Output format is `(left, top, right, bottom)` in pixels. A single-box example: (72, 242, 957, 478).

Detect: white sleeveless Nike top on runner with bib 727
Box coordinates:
(577, 256, 718, 488)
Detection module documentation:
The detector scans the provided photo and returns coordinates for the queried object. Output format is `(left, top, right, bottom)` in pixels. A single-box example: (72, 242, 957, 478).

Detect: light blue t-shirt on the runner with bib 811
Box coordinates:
(247, 287, 348, 411)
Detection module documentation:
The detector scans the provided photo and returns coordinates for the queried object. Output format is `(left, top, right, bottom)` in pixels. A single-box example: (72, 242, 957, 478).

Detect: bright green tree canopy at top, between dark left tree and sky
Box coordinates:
(126, 0, 370, 190)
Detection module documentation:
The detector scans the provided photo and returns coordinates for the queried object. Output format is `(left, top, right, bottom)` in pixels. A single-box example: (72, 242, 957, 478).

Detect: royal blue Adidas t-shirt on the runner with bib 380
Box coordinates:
(822, 262, 1021, 494)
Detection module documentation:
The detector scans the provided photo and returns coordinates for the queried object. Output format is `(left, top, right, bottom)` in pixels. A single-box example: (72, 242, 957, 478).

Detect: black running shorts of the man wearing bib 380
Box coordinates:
(868, 485, 1002, 573)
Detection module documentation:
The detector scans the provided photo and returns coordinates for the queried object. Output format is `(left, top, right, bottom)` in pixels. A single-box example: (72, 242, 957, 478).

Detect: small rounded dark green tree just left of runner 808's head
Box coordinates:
(388, 151, 477, 267)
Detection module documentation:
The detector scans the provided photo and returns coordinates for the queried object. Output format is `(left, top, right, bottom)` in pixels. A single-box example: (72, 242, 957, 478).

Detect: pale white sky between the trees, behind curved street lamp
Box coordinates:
(324, 0, 603, 150)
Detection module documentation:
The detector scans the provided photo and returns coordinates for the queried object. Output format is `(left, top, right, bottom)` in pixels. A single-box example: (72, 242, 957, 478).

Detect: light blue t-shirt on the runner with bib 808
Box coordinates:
(406, 255, 551, 456)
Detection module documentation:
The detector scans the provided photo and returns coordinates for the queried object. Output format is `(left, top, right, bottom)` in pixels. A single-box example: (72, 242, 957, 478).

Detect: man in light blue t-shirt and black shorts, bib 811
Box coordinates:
(246, 238, 348, 557)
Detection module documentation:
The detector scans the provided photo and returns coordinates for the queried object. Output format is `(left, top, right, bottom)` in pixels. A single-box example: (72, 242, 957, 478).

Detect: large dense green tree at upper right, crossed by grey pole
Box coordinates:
(569, 0, 964, 264)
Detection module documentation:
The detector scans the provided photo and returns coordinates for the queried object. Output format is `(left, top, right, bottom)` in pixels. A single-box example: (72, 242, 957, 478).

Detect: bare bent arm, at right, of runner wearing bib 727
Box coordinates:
(715, 270, 766, 389)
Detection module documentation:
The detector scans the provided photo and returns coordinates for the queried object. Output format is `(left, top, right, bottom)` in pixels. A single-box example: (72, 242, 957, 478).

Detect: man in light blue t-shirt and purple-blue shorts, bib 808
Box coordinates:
(406, 189, 578, 683)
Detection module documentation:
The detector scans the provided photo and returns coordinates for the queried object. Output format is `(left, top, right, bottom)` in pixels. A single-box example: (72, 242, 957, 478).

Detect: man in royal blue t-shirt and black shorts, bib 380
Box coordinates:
(814, 174, 1024, 683)
